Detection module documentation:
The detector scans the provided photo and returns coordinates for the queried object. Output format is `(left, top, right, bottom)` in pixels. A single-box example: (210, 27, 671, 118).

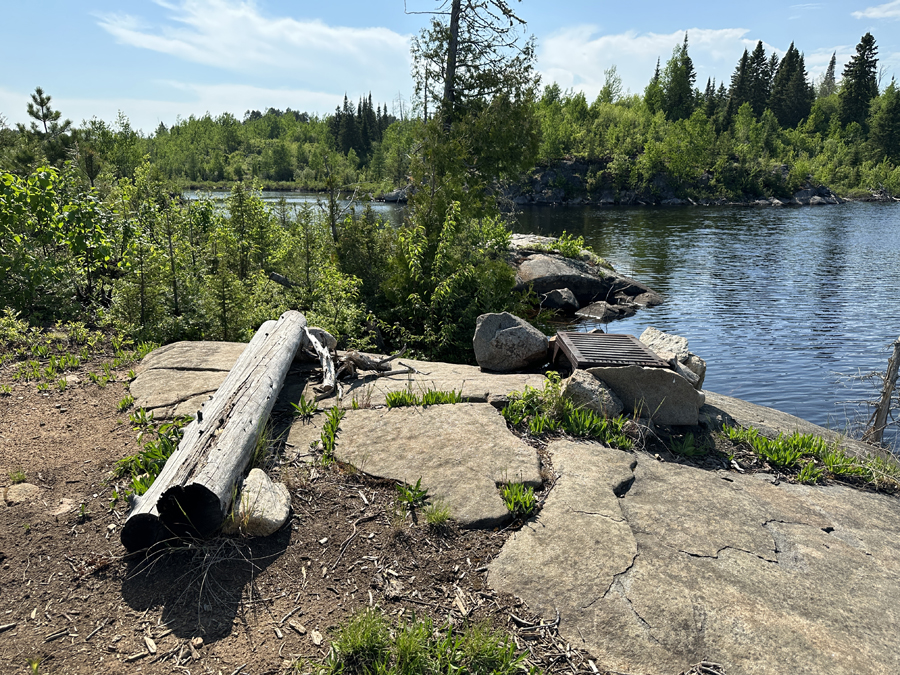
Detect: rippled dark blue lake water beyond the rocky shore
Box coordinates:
(192, 192, 900, 444)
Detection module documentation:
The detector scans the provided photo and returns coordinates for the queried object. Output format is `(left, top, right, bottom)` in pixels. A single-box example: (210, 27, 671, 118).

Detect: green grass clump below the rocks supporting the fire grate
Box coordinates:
(502, 372, 634, 450)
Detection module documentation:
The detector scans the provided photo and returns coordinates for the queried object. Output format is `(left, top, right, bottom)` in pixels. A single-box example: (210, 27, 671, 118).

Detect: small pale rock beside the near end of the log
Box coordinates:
(222, 469, 291, 537)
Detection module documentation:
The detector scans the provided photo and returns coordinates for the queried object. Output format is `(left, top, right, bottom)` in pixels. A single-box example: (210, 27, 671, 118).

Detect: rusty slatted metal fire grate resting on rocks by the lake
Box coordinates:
(553, 332, 669, 369)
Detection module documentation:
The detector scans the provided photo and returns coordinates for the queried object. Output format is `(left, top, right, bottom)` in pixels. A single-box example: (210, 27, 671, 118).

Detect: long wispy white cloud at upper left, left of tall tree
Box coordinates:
(99, 0, 409, 91)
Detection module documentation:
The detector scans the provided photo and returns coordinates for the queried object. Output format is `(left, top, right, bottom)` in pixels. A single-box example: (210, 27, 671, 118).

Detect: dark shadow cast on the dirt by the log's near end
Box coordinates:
(122, 527, 291, 643)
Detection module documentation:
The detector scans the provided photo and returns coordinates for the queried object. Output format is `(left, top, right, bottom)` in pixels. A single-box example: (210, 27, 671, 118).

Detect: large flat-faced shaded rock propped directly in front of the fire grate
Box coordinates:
(587, 366, 705, 426)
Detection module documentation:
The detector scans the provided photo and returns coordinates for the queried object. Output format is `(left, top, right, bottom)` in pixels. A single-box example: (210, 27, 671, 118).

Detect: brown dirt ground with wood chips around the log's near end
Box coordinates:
(0, 364, 620, 675)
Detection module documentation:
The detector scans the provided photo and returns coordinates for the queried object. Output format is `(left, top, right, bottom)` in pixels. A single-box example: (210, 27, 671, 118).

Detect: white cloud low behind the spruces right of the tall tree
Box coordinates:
(538, 25, 768, 101)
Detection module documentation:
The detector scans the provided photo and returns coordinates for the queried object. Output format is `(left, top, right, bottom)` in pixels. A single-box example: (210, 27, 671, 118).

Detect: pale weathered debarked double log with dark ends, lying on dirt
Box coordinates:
(121, 311, 307, 551)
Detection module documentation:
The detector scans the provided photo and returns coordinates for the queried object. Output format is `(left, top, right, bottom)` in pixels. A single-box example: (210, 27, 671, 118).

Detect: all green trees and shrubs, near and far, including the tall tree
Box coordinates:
(0, 18, 900, 361)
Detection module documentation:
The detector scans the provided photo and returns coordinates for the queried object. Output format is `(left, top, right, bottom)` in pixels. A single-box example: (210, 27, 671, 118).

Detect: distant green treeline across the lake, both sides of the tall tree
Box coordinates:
(0, 33, 900, 198)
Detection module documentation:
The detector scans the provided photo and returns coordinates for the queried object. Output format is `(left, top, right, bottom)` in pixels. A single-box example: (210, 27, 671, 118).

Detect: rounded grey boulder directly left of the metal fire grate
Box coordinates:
(472, 312, 549, 372)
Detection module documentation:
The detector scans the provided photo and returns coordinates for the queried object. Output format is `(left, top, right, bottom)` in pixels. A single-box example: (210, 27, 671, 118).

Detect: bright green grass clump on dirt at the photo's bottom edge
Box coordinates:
(320, 609, 524, 675)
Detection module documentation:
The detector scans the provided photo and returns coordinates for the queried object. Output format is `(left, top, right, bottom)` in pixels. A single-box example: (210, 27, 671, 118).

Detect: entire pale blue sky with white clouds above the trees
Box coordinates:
(0, 0, 900, 132)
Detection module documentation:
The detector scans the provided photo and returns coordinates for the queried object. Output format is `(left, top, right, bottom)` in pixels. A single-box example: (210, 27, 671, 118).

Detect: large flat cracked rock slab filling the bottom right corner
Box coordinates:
(489, 441, 900, 675)
